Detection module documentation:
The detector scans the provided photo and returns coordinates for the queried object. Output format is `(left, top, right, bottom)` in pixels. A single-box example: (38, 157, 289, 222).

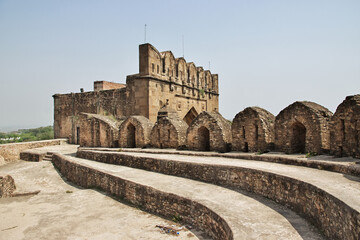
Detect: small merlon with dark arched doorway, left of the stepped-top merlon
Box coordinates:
(119, 116, 154, 148)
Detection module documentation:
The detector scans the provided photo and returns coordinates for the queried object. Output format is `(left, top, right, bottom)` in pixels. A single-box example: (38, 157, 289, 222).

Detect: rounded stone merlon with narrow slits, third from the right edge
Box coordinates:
(231, 107, 275, 152)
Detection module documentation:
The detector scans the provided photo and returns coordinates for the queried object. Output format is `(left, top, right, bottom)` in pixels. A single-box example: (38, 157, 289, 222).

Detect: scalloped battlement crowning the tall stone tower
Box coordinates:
(139, 43, 219, 93)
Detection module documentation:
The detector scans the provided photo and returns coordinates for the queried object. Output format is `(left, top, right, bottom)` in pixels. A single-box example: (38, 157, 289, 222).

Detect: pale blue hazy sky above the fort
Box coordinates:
(0, 0, 360, 130)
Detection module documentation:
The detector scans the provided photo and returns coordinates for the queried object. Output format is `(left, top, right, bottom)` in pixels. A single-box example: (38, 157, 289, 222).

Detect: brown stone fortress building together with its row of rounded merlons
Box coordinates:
(53, 43, 360, 158)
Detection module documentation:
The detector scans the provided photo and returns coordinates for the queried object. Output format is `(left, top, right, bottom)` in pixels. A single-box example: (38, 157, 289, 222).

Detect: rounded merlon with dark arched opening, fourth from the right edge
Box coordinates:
(186, 112, 231, 152)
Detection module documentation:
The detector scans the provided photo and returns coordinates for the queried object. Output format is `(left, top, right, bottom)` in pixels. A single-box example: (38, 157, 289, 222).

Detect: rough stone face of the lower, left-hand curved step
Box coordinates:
(52, 153, 233, 240)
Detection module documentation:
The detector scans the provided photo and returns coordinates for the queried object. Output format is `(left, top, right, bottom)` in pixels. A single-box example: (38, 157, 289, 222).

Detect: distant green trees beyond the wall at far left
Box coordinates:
(0, 126, 54, 144)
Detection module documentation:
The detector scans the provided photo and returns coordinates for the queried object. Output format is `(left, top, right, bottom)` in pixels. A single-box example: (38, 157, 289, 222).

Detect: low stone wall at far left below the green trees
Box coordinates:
(0, 139, 67, 165)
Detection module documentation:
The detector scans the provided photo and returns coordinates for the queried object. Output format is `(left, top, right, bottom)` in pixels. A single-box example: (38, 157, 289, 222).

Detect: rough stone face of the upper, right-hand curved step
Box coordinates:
(77, 150, 360, 240)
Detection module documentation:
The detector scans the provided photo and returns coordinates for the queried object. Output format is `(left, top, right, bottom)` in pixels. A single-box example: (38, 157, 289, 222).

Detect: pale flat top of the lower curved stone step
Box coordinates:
(53, 154, 323, 239)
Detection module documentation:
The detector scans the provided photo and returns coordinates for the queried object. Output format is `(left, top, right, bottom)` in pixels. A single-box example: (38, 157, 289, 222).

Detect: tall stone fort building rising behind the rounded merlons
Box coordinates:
(53, 44, 219, 143)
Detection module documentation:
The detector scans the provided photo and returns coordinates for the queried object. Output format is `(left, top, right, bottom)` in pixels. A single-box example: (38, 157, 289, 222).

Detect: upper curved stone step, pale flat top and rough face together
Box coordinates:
(77, 150, 360, 239)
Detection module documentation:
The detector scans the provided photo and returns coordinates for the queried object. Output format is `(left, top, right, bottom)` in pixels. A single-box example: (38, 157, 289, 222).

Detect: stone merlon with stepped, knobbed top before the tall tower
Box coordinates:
(150, 106, 188, 148)
